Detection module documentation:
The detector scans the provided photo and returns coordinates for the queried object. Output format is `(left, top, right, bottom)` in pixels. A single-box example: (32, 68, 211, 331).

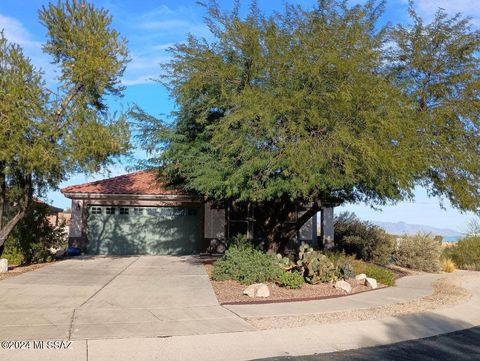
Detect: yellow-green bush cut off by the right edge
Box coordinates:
(443, 235, 480, 271)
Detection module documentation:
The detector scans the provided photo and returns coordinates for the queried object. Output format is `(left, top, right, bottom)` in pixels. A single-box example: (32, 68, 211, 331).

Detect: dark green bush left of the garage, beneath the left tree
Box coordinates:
(6, 204, 66, 264)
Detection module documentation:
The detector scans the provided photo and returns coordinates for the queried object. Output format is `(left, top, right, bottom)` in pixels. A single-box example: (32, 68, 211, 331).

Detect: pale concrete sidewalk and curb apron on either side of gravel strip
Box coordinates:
(0, 272, 480, 361)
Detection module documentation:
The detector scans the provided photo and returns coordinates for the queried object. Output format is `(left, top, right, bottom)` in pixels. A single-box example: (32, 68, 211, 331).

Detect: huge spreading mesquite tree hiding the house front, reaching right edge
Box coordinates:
(136, 0, 480, 248)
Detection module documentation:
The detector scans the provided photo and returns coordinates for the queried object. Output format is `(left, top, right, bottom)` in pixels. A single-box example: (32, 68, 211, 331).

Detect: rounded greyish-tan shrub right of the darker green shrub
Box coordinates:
(394, 233, 442, 272)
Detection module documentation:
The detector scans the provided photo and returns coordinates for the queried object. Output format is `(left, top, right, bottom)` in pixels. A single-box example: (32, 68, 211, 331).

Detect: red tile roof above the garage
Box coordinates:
(61, 171, 184, 195)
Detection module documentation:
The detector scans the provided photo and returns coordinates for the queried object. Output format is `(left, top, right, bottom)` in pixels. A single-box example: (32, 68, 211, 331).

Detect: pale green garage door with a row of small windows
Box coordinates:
(87, 206, 202, 255)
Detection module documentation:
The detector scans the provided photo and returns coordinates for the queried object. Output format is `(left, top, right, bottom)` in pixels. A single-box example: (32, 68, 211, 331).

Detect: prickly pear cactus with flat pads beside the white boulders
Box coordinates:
(297, 243, 337, 284)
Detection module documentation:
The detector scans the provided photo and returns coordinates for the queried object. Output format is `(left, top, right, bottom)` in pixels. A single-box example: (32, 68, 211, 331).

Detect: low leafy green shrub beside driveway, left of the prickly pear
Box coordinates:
(212, 243, 283, 285)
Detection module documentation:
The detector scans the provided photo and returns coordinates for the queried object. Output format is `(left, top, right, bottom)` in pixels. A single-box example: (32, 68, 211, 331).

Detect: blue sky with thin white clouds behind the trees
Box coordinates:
(0, 0, 480, 231)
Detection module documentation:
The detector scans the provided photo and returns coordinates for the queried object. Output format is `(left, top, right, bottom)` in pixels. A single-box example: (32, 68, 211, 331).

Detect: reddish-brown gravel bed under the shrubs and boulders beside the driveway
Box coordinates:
(205, 264, 386, 305)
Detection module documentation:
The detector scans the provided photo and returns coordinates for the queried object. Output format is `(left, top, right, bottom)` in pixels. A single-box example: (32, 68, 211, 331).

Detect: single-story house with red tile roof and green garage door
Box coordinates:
(61, 171, 333, 255)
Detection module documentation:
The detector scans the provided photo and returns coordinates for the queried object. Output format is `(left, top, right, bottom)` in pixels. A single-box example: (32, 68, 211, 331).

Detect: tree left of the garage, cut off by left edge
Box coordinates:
(0, 0, 129, 253)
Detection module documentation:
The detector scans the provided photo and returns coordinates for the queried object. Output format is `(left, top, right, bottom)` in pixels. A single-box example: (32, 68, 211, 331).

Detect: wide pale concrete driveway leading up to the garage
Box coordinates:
(0, 256, 251, 340)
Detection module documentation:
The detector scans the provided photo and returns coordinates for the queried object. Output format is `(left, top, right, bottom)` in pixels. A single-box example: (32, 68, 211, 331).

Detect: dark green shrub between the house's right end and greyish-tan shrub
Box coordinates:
(335, 212, 395, 264)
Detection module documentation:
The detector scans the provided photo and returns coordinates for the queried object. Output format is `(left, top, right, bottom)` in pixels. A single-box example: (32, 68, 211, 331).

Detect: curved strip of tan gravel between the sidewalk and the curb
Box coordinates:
(246, 275, 471, 330)
